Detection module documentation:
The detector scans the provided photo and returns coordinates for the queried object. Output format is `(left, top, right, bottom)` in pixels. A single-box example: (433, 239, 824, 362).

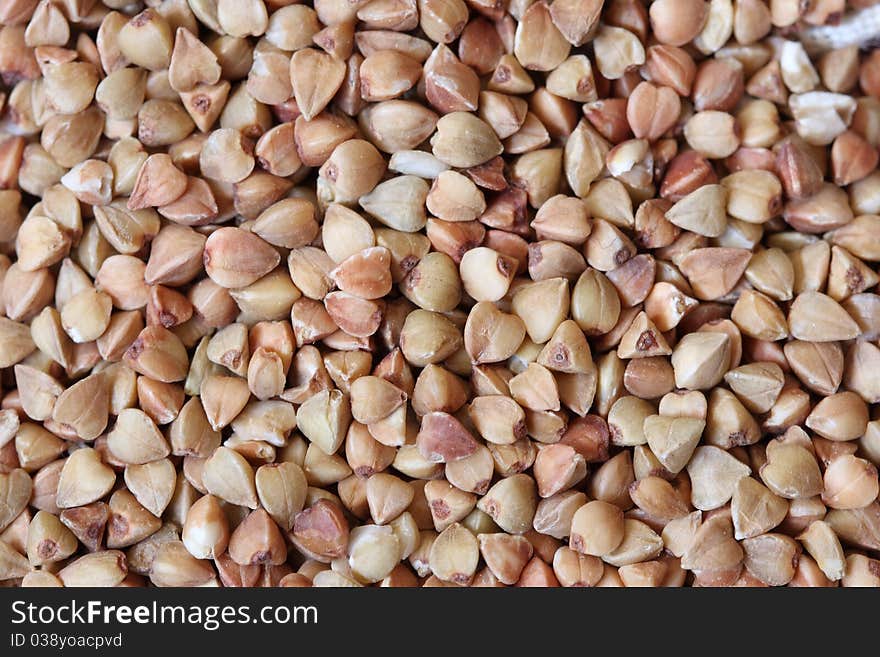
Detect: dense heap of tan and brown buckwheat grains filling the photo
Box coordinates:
(0, 0, 880, 587)
